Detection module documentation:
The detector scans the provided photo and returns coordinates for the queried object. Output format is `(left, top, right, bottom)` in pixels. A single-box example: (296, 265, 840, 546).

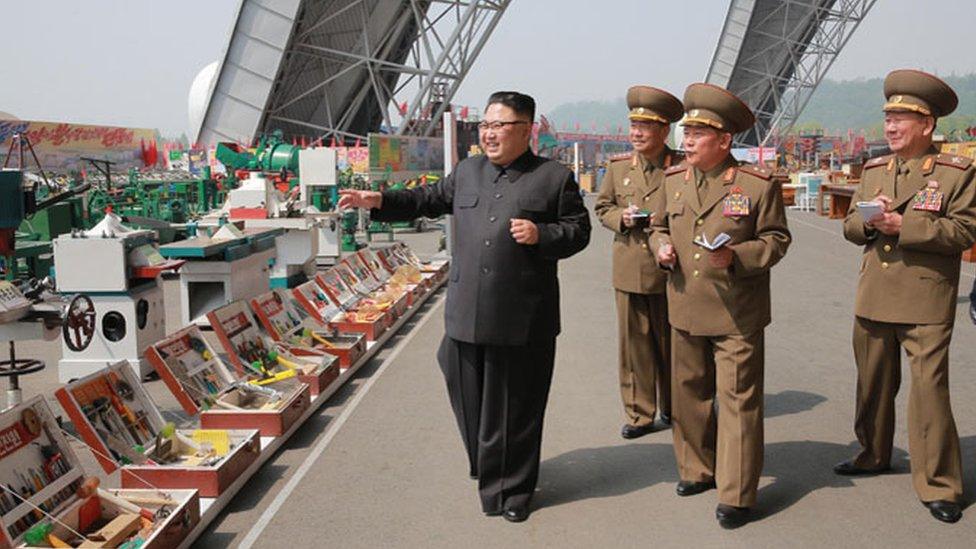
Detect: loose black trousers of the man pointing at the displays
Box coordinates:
(437, 336, 556, 512)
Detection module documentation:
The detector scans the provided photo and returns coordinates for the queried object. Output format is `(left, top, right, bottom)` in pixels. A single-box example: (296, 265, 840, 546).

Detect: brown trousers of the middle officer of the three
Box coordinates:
(671, 328, 764, 507)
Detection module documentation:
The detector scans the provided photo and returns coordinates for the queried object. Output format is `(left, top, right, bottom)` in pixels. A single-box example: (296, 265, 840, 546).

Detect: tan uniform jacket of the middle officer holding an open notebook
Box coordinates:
(651, 156, 792, 336)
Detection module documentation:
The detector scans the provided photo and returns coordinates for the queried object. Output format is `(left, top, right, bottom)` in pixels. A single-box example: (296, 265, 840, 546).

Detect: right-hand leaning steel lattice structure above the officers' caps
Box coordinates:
(707, 0, 876, 146)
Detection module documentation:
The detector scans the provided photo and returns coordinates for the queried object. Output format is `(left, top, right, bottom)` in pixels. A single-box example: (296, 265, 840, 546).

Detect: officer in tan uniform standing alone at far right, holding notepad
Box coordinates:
(834, 70, 976, 522)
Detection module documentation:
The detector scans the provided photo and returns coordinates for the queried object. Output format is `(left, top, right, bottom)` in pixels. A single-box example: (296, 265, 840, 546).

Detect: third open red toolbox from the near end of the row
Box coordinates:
(146, 326, 311, 437)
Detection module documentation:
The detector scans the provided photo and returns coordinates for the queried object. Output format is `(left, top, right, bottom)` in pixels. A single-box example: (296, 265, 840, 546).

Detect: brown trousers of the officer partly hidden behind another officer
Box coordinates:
(615, 290, 671, 427)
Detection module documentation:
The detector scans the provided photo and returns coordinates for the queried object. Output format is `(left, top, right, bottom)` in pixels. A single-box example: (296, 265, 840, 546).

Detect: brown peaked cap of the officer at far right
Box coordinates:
(884, 69, 959, 118)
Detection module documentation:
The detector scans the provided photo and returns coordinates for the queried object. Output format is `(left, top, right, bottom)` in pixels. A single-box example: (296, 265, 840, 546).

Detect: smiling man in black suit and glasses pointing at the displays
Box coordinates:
(339, 92, 590, 522)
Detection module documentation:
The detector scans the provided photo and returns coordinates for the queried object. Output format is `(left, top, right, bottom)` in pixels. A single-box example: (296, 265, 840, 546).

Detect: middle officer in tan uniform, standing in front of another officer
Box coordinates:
(651, 84, 791, 528)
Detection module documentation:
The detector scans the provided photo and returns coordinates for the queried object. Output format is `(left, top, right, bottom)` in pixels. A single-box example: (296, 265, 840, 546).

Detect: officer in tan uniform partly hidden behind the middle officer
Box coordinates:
(595, 86, 684, 439)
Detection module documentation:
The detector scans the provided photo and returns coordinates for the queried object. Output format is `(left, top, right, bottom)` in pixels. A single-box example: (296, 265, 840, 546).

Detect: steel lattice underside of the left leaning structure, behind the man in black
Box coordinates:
(261, 0, 511, 142)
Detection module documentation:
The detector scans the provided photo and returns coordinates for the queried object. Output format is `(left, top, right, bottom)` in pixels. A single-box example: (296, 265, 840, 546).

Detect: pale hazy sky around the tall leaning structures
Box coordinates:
(0, 0, 976, 136)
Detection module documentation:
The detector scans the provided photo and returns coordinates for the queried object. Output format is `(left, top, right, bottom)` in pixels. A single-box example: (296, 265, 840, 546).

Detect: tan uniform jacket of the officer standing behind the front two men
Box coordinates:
(594, 147, 678, 294)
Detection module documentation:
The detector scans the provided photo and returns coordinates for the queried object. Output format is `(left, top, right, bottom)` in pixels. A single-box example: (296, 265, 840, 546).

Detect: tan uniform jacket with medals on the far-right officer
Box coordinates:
(844, 148, 976, 324)
